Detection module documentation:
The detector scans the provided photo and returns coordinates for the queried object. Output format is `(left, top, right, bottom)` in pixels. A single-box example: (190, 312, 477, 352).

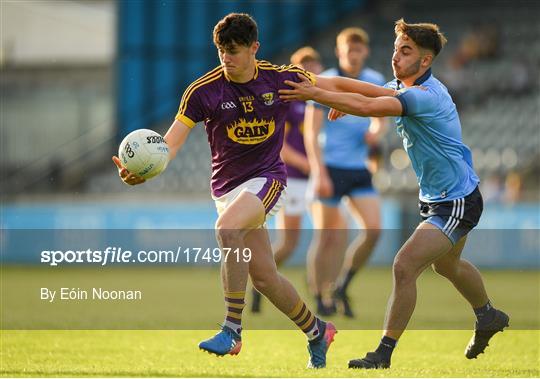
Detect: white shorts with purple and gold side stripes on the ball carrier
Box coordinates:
(212, 177, 286, 217)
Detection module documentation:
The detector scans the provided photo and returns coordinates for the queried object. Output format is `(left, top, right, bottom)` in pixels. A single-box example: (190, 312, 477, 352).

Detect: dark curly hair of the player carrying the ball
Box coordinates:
(214, 13, 258, 50)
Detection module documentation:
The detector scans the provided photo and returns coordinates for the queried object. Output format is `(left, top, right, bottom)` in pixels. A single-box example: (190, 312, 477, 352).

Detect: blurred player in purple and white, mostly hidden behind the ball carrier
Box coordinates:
(251, 46, 322, 313)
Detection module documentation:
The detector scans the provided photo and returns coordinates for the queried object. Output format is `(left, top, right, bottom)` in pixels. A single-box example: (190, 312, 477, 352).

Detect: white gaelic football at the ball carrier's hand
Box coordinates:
(118, 129, 169, 179)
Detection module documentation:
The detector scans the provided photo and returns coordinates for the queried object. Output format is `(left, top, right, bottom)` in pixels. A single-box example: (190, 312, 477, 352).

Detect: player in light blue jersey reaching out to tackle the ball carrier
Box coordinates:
(280, 19, 509, 369)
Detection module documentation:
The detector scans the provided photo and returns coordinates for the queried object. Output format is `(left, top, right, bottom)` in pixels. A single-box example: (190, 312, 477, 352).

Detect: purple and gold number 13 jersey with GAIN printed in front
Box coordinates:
(176, 61, 315, 197)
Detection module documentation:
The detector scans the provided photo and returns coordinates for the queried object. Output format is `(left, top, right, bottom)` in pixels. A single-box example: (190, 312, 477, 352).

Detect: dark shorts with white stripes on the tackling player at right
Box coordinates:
(418, 187, 484, 245)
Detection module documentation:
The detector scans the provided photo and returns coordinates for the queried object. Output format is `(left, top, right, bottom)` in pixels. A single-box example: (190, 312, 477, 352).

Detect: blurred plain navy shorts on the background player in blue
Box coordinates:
(317, 166, 377, 207)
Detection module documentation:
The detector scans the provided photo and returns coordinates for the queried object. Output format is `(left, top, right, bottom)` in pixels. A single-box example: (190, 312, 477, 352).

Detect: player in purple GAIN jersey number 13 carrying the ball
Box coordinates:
(113, 13, 336, 368)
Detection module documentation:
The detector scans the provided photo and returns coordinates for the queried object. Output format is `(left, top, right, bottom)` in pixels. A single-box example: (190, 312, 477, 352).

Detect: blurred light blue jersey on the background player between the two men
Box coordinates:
(316, 68, 385, 169)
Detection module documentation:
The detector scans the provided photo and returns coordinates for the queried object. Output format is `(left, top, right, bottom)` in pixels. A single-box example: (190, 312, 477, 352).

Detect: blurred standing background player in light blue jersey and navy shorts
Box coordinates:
(305, 27, 385, 317)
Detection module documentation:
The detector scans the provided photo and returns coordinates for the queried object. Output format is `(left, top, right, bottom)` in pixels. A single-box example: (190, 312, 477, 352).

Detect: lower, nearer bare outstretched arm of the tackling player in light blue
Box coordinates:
(279, 79, 403, 117)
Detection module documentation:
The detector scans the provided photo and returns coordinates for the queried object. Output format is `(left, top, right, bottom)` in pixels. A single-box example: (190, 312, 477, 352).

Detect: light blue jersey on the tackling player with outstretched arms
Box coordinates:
(386, 69, 480, 202)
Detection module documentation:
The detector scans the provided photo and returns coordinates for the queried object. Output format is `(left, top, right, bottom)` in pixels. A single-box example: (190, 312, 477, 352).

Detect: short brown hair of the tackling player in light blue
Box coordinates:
(394, 18, 446, 56)
